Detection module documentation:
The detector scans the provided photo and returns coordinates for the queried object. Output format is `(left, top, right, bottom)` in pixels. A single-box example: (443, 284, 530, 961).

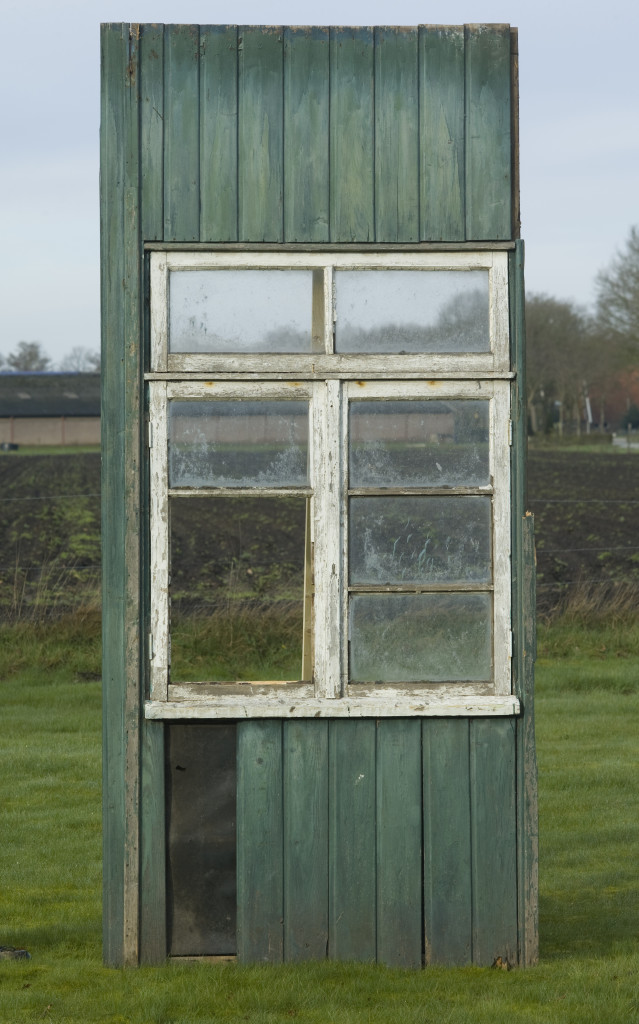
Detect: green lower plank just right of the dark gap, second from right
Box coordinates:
(422, 718, 472, 965)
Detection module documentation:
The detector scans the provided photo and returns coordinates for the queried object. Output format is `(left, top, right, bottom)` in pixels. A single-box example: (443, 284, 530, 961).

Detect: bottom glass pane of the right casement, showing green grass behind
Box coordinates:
(349, 594, 493, 683)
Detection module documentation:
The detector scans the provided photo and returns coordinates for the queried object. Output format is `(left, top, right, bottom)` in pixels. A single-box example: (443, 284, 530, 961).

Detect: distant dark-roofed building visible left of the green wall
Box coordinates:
(0, 371, 100, 445)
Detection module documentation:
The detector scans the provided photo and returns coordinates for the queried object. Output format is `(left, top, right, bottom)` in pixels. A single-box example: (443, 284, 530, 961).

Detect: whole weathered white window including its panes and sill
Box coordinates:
(146, 252, 518, 718)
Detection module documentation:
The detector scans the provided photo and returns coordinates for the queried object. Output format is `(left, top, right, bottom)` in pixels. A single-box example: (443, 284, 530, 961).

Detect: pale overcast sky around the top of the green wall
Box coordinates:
(0, 0, 639, 359)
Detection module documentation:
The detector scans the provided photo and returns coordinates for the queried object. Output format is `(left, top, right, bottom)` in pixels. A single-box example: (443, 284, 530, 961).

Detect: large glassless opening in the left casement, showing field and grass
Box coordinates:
(170, 497, 310, 683)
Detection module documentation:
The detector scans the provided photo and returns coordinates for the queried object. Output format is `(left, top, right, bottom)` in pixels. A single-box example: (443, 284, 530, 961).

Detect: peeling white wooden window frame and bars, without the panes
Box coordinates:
(145, 251, 519, 719)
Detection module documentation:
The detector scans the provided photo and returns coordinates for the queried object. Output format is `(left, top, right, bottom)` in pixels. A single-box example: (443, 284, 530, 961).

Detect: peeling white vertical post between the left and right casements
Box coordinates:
(312, 381, 342, 698)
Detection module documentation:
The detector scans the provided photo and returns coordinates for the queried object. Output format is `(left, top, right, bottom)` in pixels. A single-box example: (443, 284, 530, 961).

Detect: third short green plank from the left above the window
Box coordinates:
(200, 25, 238, 242)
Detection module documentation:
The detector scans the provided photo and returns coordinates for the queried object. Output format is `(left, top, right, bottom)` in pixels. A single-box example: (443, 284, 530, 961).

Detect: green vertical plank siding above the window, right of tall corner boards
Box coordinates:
(136, 25, 517, 244)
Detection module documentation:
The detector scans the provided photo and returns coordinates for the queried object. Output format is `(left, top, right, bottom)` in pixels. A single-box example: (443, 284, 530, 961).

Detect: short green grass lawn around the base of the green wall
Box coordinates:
(0, 622, 639, 1024)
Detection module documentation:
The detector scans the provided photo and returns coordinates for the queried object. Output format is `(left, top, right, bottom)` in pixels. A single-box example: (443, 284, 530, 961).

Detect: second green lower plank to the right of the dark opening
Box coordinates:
(284, 719, 329, 962)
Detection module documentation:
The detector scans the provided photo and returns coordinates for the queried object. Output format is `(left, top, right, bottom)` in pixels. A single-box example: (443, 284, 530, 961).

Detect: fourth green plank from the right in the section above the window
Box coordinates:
(330, 28, 375, 242)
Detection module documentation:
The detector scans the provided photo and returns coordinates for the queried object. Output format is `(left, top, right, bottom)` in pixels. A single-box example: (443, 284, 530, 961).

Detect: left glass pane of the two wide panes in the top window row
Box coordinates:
(169, 270, 312, 353)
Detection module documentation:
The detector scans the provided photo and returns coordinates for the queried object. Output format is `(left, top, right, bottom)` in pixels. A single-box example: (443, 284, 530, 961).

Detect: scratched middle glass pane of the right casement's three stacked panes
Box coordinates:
(349, 496, 491, 584)
